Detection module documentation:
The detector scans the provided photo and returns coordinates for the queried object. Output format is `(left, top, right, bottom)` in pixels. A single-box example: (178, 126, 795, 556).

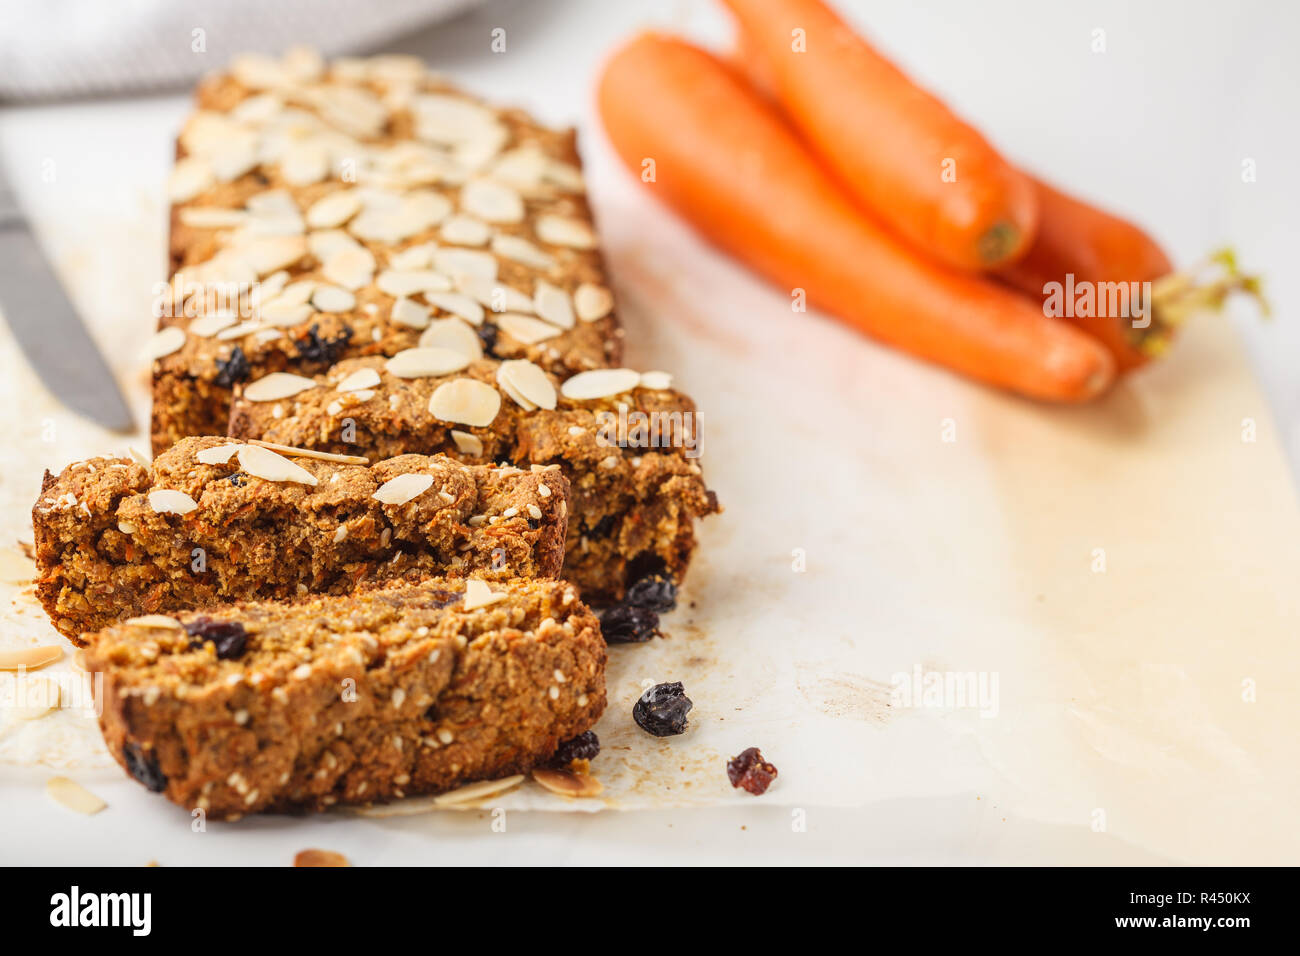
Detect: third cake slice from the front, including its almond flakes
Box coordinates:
(230, 356, 719, 602)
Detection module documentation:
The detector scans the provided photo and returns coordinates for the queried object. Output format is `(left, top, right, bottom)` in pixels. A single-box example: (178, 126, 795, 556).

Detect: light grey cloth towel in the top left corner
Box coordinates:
(0, 0, 477, 100)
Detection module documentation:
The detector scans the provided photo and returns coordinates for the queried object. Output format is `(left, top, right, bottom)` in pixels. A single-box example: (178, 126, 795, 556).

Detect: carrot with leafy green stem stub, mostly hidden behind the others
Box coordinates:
(998, 181, 1262, 372)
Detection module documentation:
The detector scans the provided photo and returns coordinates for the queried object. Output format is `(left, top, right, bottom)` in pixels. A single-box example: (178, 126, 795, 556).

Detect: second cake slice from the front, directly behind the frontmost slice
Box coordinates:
(33, 437, 568, 643)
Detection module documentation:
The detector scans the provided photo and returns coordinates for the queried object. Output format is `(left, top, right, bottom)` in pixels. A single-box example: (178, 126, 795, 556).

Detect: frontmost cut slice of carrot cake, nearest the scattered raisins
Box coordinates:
(86, 580, 606, 819)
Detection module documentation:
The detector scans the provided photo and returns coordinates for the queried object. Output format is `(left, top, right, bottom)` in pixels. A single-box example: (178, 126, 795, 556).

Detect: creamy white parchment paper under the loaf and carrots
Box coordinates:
(0, 93, 1300, 862)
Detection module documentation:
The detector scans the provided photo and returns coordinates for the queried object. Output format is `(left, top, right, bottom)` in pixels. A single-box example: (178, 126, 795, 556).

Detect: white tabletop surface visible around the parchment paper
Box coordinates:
(0, 0, 1300, 865)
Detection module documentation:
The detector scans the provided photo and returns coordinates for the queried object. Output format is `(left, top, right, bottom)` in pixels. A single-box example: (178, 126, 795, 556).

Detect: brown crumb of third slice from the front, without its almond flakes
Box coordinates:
(230, 356, 720, 602)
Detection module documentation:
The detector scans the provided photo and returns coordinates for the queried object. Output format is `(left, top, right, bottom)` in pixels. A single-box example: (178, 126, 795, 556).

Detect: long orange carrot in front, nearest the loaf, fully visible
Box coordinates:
(597, 34, 1114, 402)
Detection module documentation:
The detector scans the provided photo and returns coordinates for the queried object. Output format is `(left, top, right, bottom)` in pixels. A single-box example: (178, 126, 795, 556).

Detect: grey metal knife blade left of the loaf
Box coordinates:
(0, 166, 135, 432)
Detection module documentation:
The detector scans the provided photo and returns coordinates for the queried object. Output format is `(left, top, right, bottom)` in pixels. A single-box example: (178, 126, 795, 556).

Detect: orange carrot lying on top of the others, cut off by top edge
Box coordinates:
(724, 0, 1037, 272)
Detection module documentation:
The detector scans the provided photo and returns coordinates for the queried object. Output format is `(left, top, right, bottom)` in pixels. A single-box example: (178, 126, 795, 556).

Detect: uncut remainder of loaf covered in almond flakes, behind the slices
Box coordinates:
(151, 51, 623, 454)
